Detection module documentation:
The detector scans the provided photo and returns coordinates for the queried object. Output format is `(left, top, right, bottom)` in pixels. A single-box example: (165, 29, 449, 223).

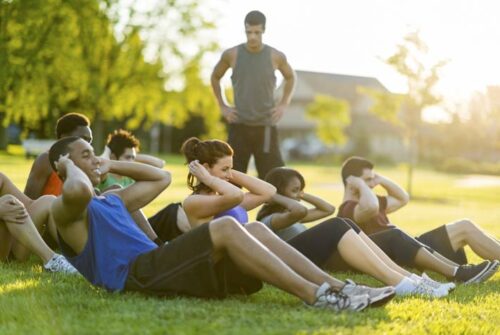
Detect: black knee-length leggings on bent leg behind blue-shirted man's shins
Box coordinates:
(287, 218, 361, 268)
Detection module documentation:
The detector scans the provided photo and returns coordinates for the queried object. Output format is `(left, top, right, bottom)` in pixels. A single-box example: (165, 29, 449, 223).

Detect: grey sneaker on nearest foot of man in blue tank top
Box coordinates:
(310, 282, 370, 312)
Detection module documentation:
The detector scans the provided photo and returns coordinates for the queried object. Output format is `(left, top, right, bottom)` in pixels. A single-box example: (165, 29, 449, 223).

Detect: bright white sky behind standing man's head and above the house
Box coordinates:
(204, 0, 500, 121)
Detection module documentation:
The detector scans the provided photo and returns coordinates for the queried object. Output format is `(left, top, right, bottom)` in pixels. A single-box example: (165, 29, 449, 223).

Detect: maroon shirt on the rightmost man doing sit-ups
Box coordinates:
(337, 196, 395, 235)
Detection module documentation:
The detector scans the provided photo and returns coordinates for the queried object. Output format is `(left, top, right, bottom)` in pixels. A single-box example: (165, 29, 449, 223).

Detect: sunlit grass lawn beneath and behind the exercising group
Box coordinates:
(0, 153, 500, 335)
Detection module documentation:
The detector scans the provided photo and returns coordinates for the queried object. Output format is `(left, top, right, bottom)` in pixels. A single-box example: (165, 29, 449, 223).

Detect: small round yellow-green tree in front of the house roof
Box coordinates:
(306, 94, 351, 145)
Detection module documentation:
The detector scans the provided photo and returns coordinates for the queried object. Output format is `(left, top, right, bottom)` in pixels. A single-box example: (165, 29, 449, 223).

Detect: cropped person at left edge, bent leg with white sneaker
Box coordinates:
(0, 173, 77, 273)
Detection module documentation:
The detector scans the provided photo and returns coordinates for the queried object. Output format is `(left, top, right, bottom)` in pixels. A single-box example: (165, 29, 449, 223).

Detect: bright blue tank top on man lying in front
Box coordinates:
(59, 194, 157, 291)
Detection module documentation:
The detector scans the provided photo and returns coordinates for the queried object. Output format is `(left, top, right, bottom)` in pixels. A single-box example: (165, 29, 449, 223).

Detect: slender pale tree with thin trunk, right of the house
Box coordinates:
(362, 32, 447, 195)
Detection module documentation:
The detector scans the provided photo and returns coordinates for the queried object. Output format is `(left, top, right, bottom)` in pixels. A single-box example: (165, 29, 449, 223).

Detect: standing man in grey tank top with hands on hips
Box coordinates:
(211, 11, 295, 179)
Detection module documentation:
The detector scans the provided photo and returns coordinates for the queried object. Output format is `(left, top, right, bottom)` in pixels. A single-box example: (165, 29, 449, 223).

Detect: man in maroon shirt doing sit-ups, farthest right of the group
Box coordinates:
(338, 157, 500, 284)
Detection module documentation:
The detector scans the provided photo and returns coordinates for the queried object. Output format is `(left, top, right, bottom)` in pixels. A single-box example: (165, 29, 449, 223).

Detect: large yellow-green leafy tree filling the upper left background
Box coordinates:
(0, 0, 221, 148)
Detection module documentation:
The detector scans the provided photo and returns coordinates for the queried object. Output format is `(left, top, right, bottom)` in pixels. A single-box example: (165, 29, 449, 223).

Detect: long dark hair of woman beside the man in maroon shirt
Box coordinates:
(257, 167, 306, 220)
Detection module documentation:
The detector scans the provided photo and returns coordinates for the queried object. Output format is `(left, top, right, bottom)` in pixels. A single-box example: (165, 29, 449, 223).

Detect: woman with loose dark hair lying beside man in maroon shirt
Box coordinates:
(257, 167, 455, 297)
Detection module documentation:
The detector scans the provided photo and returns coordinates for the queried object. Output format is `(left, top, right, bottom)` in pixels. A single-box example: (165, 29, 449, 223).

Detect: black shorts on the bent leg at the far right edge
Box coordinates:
(415, 225, 467, 265)
